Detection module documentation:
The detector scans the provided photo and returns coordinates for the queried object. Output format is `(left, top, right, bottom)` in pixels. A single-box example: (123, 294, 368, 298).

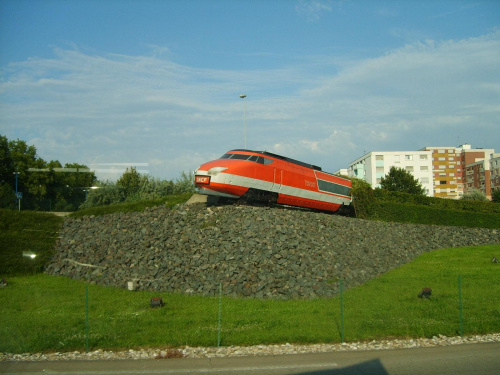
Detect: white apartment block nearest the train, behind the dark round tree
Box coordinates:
(348, 150, 434, 196)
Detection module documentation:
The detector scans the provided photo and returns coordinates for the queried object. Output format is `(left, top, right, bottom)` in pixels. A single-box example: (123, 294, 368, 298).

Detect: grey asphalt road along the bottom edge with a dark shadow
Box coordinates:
(0, 343, 500, 375)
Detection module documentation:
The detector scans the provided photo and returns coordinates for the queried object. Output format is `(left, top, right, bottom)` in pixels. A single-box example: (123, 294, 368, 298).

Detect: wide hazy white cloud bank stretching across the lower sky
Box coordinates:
(0, 32, 500, 179)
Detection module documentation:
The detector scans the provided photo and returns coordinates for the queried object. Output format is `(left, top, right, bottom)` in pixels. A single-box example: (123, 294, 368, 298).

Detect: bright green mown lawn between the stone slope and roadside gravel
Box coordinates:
(0, 245, 500, 353)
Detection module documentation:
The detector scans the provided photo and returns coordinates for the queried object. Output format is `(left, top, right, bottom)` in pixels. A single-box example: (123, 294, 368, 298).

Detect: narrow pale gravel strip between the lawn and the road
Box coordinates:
(0, 333, 500, 361)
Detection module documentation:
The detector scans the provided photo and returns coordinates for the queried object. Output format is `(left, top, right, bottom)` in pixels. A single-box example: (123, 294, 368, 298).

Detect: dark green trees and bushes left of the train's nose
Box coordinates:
(0, 135, 195, 211)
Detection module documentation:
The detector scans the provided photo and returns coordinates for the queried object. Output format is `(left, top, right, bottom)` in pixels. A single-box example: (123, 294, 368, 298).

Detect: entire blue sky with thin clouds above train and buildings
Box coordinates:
(0, 0, 500, 180)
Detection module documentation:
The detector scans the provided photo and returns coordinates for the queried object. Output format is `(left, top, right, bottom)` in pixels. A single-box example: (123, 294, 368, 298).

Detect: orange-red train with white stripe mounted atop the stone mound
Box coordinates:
(194, 150, 351, 211)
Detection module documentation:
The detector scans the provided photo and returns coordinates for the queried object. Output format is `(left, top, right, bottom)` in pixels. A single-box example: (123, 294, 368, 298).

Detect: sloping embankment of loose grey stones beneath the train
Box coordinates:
(46, 204, 500, 299)
